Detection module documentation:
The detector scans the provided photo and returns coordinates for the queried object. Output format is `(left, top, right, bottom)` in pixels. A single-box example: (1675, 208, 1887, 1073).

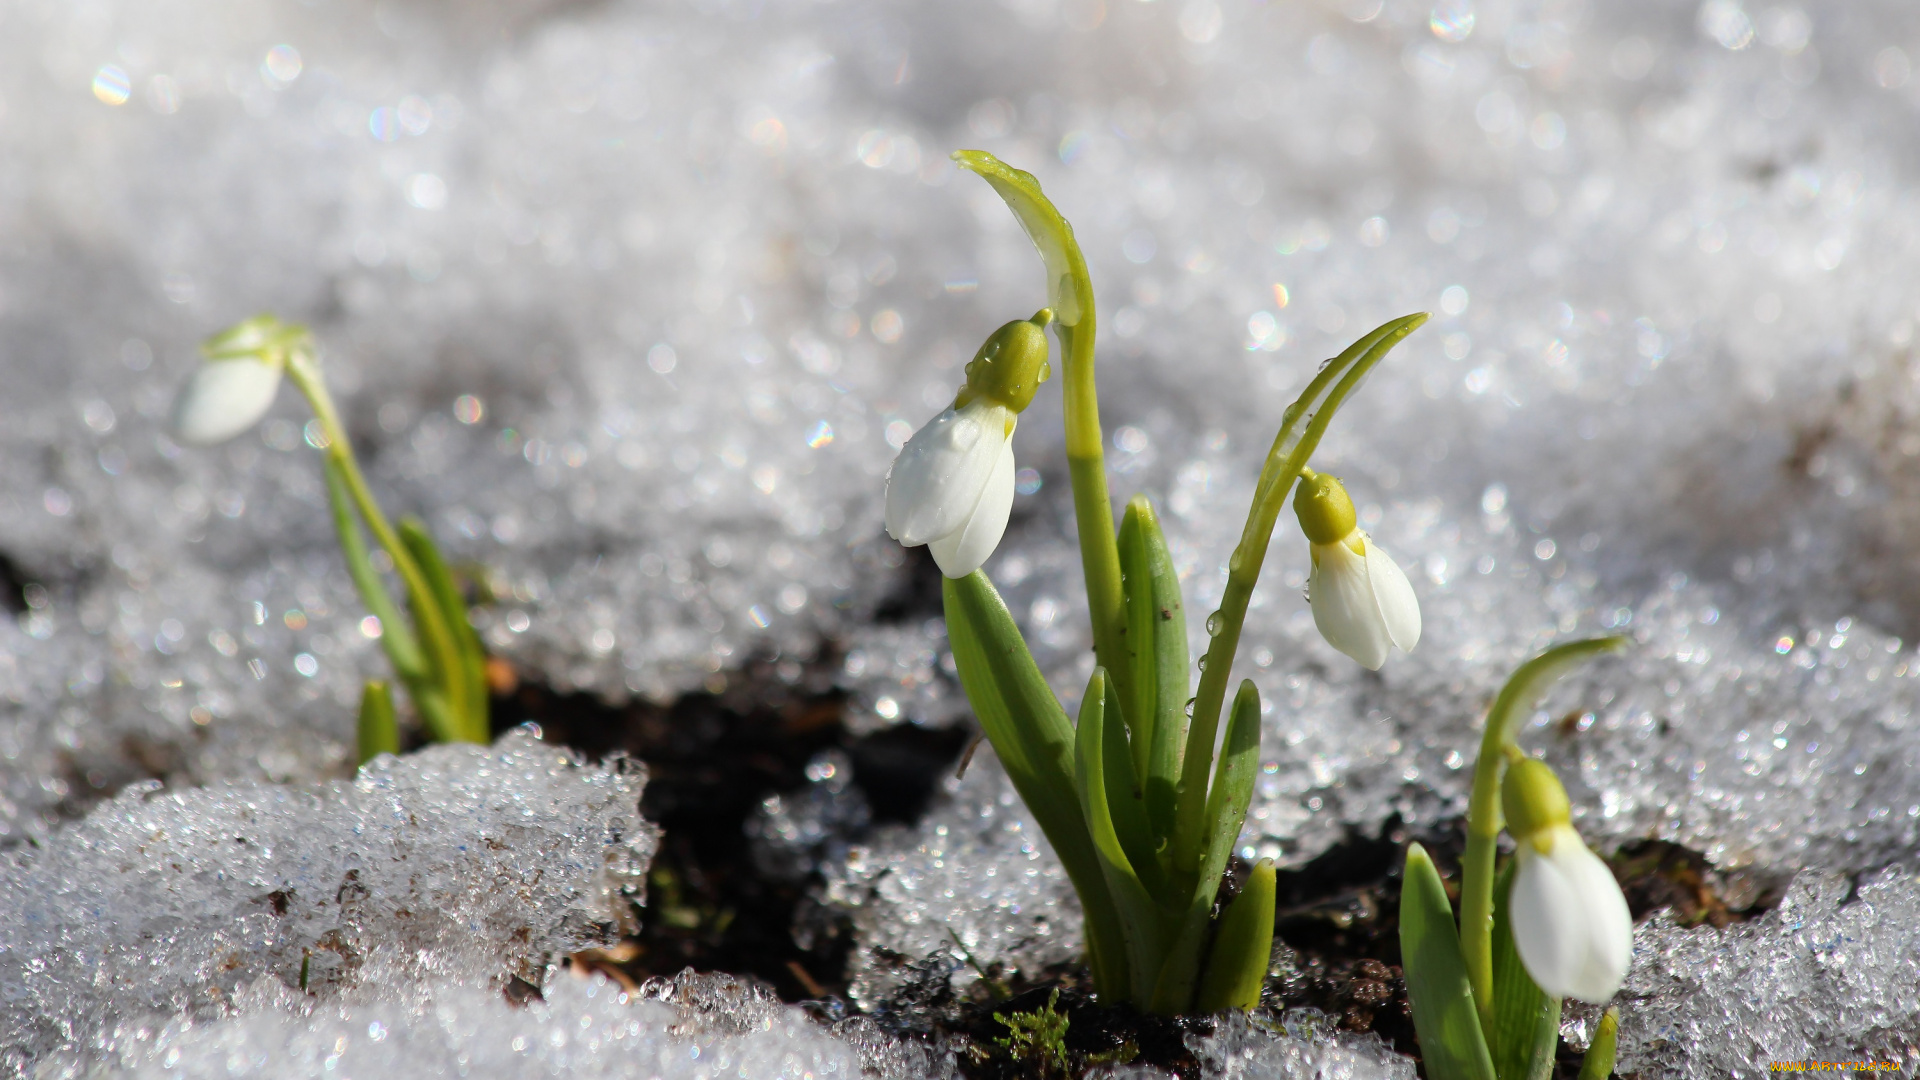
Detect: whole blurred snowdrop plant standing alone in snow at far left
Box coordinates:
(173, 315, 492, 763)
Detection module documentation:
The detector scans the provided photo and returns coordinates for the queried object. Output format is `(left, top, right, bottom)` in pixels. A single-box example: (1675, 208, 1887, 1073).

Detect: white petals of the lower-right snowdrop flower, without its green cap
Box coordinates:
(1507, 824, 1634, 1005)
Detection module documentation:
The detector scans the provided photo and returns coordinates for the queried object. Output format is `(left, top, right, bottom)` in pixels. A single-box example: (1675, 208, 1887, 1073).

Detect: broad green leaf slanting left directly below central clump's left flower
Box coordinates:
(941, 571, 1129, 1001)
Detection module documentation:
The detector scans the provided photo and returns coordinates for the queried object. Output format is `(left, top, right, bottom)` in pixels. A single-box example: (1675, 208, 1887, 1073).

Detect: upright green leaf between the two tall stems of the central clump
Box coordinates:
(1119, 496, 1188, 840)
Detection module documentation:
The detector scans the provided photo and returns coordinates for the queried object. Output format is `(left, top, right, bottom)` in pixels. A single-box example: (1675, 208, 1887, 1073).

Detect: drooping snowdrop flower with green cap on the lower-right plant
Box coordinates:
(1501, 757, 1634, 1005)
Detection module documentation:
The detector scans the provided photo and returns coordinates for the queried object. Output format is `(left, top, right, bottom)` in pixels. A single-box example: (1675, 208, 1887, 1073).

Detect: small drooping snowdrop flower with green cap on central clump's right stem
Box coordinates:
(1294, 473, 1421, 671)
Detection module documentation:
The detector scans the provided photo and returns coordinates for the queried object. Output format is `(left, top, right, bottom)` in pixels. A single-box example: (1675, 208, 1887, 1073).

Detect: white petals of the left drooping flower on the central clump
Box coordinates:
(887, 400, 1012, 548)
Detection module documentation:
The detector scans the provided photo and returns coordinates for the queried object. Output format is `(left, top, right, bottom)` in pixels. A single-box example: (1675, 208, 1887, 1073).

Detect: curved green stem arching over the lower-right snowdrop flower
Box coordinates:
(1459, 638, 1626, 1030)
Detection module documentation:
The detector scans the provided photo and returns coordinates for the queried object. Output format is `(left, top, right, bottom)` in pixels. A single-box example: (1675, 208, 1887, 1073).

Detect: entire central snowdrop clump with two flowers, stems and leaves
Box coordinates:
(887, 150, 1427, 1015)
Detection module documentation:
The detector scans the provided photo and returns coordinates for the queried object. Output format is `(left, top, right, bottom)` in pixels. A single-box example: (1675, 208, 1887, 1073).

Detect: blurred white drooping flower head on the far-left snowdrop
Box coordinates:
(173, 315, 305, 446)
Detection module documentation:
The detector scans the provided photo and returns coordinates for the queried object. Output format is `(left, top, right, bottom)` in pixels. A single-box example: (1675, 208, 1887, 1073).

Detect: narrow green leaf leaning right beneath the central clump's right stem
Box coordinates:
(1154, 678, 1260, 1013)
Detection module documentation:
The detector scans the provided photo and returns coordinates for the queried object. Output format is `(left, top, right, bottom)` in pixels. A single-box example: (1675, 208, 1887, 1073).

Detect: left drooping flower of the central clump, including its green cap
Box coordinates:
(887, 309, 1054, 578)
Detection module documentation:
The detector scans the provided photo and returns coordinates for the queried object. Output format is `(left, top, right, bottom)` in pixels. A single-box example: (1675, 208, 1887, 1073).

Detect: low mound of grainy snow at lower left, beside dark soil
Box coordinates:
(0, 734, 655, 1074)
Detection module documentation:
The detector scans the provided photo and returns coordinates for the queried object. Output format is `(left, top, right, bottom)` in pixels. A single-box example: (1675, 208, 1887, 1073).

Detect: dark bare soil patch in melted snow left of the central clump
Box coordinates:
(493, 641, 972, 1001)
